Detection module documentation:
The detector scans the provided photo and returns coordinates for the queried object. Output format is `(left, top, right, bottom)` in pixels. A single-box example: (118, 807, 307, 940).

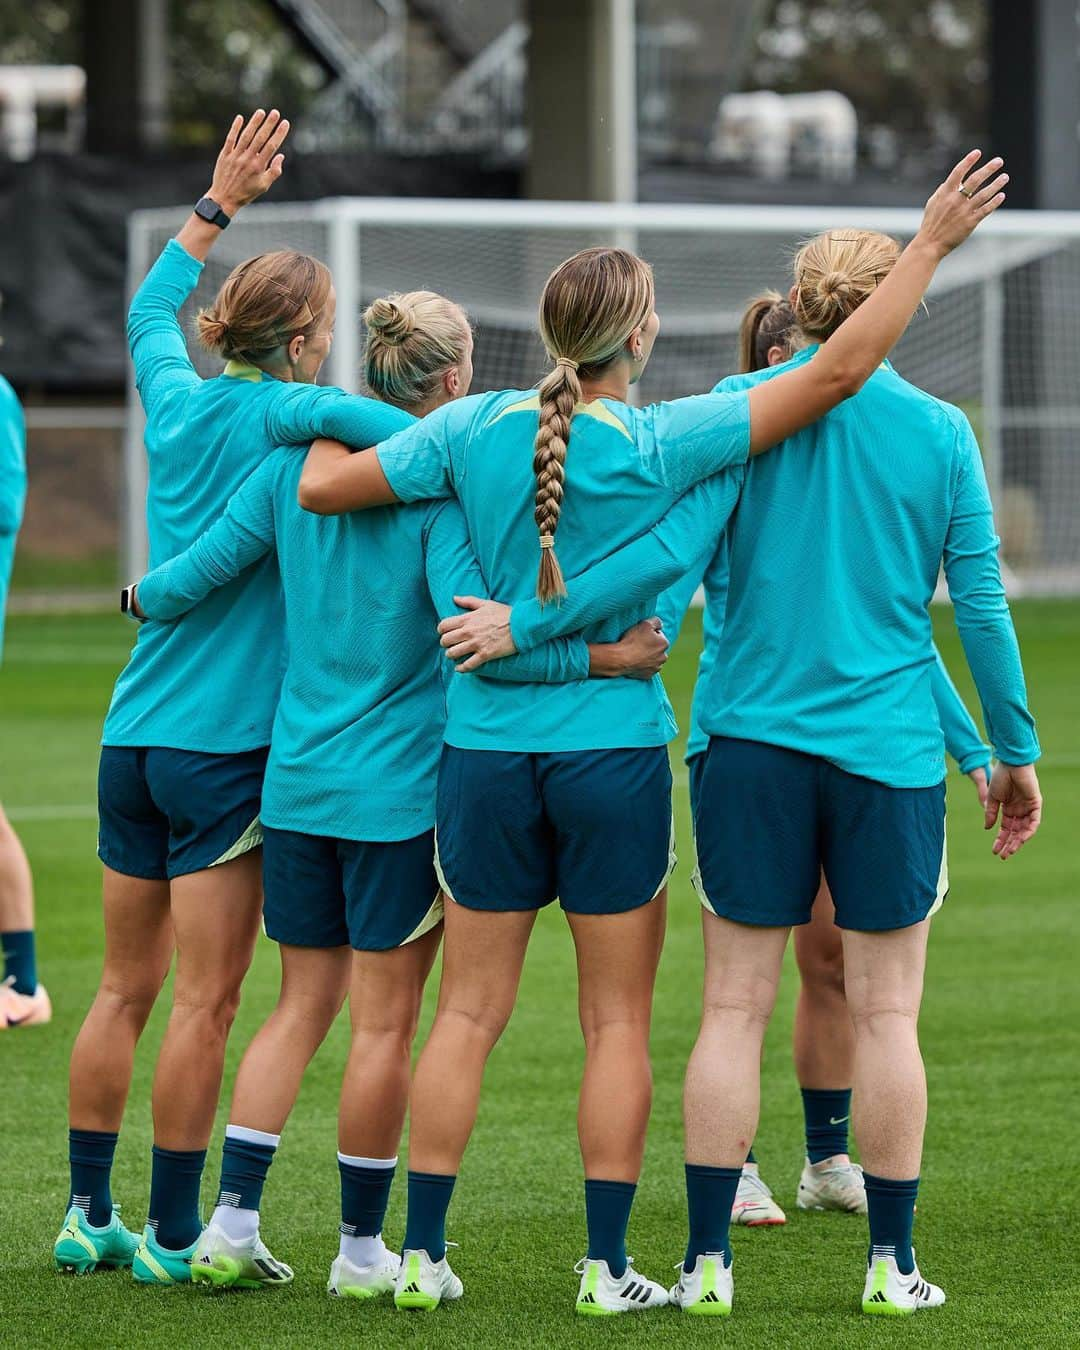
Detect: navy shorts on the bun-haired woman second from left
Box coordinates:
(262, 825, 443, 952)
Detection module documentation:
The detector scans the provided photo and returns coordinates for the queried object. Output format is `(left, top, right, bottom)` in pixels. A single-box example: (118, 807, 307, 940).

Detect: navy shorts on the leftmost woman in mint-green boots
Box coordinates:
(97, 745, 267, 882)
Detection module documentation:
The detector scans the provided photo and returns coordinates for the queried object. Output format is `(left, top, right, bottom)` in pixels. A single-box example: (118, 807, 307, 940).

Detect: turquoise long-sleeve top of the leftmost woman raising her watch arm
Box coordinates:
(103, 240, 413, 755)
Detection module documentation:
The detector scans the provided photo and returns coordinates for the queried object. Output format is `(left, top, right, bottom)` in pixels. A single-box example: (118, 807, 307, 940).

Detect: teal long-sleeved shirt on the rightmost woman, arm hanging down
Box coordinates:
(699, 348, 1040, 787)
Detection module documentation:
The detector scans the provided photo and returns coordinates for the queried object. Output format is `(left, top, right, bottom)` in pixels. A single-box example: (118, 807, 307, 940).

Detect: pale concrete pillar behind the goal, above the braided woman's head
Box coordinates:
(525, 0, 637, 201)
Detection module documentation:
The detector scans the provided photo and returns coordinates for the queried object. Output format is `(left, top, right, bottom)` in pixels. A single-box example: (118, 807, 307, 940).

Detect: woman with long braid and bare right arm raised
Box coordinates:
(291, 153, 1003, 1315)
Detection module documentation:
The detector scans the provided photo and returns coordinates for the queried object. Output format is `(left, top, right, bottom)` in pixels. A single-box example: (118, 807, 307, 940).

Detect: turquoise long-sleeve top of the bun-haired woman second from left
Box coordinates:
(139, 450, 589, 840)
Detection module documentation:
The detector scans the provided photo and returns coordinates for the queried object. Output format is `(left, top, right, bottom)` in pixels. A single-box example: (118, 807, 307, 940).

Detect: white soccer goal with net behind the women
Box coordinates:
(124, 198, 1080, 594)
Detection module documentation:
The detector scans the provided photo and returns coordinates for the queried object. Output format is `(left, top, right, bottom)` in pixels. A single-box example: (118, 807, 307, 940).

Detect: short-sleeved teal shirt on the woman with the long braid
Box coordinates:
(378, 390, 749, 752)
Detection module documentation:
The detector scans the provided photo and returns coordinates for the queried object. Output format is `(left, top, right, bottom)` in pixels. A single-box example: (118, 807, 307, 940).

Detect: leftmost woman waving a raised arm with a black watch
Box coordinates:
(54, 111, 423, 1284)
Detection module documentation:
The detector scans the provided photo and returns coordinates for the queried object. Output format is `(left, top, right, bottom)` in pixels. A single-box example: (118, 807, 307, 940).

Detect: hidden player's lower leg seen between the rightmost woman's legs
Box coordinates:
(792, 878, 867, 1214)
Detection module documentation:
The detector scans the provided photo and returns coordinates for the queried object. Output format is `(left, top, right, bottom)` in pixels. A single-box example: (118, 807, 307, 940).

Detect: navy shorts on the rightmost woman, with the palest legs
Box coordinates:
(691, 736, 949, 933)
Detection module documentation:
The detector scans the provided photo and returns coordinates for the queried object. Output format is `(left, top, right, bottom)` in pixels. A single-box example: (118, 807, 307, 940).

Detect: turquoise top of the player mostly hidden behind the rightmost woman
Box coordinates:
(656, 537, 991, 776)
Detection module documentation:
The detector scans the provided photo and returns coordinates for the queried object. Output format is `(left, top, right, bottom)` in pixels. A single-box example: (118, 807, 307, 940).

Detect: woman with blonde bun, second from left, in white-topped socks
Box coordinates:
(126, 292, 667, 1299)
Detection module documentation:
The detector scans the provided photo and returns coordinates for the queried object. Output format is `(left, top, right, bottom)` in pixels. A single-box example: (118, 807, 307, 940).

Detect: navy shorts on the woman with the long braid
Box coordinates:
(436, 745, 675, 914)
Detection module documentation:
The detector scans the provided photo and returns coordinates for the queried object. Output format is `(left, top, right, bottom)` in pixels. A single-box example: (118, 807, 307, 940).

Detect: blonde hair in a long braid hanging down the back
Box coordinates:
(532, 248, 655, 602)
